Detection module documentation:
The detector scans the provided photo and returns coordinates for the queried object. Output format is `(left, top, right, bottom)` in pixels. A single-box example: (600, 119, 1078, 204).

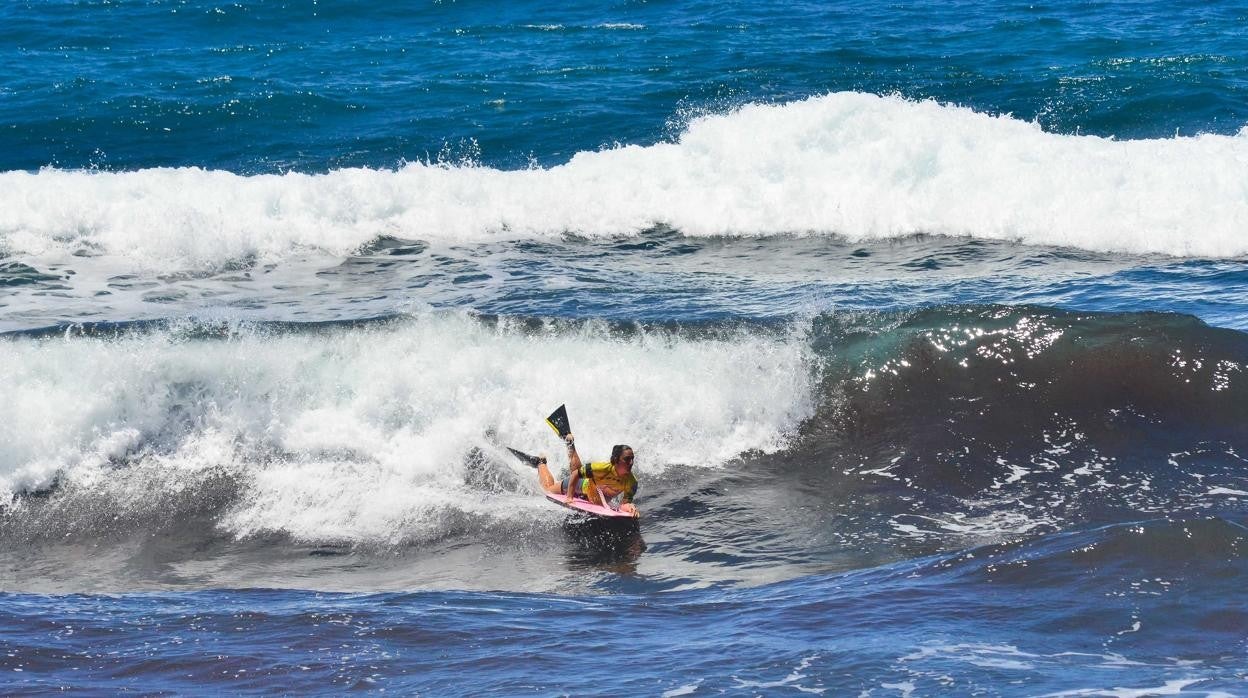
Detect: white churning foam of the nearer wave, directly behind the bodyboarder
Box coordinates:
(0, 315, 815, 543)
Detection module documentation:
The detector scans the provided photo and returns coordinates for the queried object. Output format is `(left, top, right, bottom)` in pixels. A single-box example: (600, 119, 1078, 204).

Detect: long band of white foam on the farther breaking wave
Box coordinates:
(0, 92, 1248, 270)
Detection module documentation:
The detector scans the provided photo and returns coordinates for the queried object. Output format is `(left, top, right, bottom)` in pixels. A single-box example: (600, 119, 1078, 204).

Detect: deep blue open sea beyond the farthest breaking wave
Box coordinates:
(7, 1, 1248, 174)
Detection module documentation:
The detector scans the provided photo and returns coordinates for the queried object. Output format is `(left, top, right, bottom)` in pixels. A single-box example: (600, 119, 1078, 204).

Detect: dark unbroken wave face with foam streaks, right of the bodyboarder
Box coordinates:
(648, 307, 1248, 584)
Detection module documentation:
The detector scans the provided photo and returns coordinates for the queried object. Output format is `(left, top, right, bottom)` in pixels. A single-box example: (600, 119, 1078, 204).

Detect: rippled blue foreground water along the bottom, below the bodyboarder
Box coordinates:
(0, 521, 1248, 696)
